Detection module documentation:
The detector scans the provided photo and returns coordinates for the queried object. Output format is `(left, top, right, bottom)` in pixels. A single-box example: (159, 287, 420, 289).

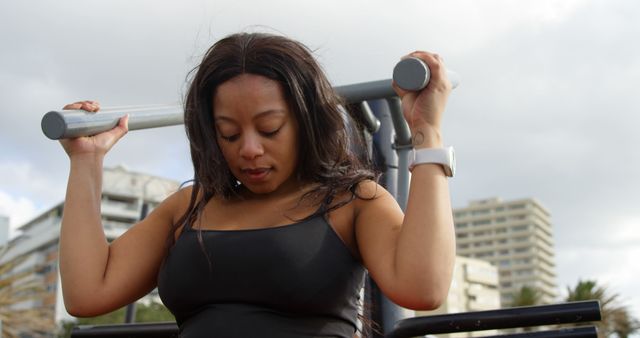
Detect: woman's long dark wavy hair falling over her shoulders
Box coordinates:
(169, 33, 377, 247)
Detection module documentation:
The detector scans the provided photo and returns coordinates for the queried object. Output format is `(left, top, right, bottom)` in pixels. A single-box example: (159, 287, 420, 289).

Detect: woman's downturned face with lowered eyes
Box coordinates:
(213, 74, 298, 194)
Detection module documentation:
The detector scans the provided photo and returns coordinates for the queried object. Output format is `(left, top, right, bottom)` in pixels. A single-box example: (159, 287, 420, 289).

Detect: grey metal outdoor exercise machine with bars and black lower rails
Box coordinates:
(41, 58, 600, 338)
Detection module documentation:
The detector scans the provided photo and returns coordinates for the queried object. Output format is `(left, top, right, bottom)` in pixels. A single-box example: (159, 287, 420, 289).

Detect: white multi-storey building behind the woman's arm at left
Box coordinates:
(0, 166, 179, 332)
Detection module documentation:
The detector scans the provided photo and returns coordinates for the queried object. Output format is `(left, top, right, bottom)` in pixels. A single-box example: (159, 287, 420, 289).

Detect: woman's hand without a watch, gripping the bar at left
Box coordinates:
(60, 101, 129, 158)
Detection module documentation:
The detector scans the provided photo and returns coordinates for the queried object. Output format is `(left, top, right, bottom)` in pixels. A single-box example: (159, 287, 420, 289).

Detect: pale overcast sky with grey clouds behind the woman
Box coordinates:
(0, 0, 640, 322)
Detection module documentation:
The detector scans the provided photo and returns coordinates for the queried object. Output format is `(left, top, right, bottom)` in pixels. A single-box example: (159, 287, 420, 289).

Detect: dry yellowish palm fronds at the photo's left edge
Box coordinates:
(0, 246, 55, 338)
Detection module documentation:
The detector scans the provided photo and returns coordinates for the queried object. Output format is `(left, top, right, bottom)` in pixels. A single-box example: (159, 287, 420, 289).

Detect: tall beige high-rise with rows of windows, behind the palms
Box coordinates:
(454, 198, 557, 306)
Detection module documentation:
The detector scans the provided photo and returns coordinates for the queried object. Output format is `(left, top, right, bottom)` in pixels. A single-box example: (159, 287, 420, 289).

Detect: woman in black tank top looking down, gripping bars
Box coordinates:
(60, 34, 454, 337)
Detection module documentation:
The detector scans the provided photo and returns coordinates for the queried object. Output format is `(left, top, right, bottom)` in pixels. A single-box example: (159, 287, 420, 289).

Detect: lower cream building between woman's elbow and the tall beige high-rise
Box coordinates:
(416, 256, 500, 337)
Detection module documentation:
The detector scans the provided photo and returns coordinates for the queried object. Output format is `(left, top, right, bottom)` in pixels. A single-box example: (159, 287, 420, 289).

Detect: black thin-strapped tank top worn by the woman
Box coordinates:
(158, 216, 364, 338)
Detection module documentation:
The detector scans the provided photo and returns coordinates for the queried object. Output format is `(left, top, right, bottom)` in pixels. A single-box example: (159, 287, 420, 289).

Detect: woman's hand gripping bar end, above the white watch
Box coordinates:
(393, 51, 452, 147)
